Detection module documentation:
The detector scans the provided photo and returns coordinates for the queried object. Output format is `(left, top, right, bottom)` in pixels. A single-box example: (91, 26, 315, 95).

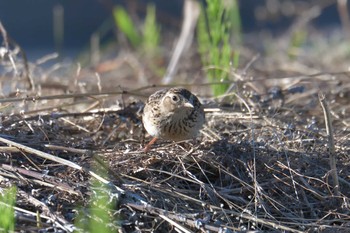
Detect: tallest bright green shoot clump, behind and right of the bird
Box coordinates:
(197, 0, 241, 96)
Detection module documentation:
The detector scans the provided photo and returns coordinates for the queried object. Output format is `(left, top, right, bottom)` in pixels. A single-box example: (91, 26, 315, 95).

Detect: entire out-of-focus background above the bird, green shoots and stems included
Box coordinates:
(0, 0, 350, 96)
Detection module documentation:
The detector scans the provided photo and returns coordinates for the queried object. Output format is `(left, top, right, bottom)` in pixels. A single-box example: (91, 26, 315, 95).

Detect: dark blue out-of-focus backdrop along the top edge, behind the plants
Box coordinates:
(0, 0, 341, 59)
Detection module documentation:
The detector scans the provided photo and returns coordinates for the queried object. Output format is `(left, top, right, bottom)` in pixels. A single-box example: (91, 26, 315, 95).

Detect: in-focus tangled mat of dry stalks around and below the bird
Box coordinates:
(0, 68, 350, 232)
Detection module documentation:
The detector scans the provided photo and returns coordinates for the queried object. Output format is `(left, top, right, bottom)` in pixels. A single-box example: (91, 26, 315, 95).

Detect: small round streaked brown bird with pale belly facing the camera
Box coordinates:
(142, 87, 205, 152)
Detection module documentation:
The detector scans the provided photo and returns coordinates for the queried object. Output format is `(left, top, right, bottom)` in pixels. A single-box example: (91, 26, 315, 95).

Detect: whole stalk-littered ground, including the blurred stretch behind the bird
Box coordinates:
(0, 5, 350, 232)
